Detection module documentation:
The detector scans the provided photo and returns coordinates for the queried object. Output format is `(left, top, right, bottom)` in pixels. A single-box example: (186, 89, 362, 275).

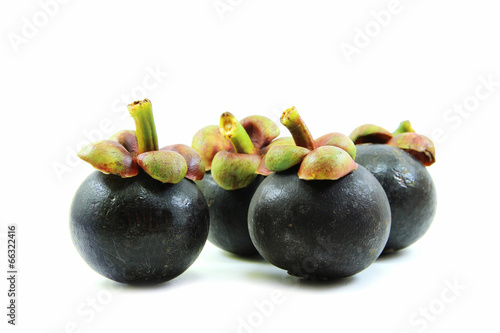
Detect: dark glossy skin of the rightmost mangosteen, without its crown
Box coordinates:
(356, 144, 437, 252)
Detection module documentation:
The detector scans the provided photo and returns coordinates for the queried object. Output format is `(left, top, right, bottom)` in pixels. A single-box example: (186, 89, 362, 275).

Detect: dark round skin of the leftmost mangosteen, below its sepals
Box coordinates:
(70, 171, 209, 284)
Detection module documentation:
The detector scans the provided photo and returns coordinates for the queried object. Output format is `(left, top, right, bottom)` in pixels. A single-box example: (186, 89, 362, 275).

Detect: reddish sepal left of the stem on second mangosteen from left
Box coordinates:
(191, 125, 234, 171)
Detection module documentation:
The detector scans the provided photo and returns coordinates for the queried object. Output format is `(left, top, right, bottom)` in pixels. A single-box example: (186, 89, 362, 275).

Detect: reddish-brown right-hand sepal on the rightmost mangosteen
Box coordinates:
(387, 132, 436, 166)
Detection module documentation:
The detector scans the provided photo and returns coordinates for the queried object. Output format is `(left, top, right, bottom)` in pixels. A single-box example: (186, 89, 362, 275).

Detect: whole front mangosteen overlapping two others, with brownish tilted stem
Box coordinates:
(248, 107, 391, 280)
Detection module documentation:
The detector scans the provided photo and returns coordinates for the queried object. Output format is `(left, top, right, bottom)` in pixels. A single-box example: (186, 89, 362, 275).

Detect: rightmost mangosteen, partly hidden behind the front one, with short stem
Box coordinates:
(350, 121, 437, 253)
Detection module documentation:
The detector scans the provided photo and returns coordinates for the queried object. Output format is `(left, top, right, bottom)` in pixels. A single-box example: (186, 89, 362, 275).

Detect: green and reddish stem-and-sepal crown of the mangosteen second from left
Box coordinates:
(191, 112, 286, 190)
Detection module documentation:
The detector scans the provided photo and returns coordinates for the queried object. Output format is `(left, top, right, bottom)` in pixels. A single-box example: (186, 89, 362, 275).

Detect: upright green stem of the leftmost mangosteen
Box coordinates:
(127, 98, 158, 154)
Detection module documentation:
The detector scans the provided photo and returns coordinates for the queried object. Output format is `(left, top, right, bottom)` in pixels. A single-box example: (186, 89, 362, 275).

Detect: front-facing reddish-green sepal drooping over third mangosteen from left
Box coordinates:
(298, 146, 358, 180)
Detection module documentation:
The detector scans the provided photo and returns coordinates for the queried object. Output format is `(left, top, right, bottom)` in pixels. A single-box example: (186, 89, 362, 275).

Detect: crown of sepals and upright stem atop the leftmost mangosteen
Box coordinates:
(78, 99, 205, 184)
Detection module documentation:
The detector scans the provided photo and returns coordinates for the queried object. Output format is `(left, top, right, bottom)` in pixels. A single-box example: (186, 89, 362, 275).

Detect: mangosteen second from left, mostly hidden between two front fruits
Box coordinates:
(192, 112, 291, 257)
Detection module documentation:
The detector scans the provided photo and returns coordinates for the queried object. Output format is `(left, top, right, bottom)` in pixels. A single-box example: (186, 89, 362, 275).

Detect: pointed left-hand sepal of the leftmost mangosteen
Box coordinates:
(77, 140, 139, 178)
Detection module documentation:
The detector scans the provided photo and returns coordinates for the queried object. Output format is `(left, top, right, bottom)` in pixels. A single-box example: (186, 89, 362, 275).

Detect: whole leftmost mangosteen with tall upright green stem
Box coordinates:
(70, 99, 209, 284)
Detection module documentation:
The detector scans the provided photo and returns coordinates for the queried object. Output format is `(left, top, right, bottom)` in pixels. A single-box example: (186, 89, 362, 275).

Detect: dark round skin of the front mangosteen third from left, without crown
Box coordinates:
(248, 166, 391, 280)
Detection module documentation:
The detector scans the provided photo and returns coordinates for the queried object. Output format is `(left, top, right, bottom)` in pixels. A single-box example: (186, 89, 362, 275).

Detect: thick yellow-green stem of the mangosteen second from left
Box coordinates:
(219, 112, 256, 154)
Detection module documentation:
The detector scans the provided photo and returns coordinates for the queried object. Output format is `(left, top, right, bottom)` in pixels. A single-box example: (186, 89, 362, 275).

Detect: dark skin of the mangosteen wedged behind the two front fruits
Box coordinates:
(197, 171, 265, 257)
